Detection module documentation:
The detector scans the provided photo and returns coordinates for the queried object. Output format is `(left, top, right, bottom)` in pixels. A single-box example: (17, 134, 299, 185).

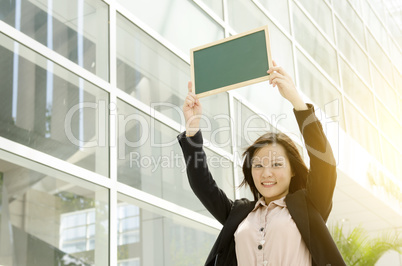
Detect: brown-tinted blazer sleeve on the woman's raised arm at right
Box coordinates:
(293, 104, 337, 221)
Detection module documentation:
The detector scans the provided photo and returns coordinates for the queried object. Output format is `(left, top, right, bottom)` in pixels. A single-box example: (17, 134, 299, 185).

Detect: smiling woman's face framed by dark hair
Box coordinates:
(251, 144, 293, 204)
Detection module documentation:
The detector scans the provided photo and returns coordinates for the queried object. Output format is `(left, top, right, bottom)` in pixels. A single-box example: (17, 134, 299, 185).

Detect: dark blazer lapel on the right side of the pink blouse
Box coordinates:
(285, 190, 311, 249)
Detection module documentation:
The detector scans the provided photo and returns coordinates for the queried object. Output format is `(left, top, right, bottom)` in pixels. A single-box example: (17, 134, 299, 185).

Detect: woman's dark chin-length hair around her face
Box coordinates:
(239, 132, 309, 200)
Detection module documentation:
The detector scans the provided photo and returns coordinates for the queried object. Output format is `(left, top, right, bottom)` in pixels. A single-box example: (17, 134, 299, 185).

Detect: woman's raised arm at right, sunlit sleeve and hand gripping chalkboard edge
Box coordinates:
(268, 62, 336, 220)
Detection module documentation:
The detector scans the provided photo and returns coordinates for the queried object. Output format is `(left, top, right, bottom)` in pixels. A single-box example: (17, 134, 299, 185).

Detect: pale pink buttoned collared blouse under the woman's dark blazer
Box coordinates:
(234, 197, 311, 266)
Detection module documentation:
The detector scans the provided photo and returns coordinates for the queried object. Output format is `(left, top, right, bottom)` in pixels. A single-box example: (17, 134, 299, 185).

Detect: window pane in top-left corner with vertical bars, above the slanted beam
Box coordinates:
(0, 0, 109, 80)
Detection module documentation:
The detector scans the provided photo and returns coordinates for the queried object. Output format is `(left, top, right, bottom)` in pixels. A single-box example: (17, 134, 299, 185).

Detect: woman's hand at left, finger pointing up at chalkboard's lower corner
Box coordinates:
(183, 81, 202, 136)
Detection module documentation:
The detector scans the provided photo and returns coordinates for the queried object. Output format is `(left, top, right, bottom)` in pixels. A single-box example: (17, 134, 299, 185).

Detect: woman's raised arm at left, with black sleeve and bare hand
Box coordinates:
(178, 82, 233, 224)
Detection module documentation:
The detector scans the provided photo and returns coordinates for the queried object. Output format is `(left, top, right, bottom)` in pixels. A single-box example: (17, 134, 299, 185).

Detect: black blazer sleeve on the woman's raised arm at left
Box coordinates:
(177, 130, 233, 225)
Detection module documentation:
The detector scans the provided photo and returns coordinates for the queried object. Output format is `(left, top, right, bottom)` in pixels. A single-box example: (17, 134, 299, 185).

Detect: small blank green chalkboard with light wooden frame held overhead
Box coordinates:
(190, 26, 272, 97)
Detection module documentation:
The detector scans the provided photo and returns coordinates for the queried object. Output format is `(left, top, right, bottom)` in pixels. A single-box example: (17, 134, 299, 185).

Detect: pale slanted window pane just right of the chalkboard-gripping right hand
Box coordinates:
(296, 50, 345, 129)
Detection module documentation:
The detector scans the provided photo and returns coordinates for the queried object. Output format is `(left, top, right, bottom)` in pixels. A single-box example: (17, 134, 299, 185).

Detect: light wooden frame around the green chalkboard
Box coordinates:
(190, 25, 272, 98)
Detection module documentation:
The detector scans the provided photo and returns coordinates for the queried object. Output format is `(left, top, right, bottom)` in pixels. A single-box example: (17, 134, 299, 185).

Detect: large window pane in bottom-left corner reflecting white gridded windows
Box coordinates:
(0, 158, 109, 266)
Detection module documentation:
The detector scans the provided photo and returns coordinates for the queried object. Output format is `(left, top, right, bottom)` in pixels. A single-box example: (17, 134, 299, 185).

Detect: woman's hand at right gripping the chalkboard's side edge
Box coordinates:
(267, 61, 307, 110)
